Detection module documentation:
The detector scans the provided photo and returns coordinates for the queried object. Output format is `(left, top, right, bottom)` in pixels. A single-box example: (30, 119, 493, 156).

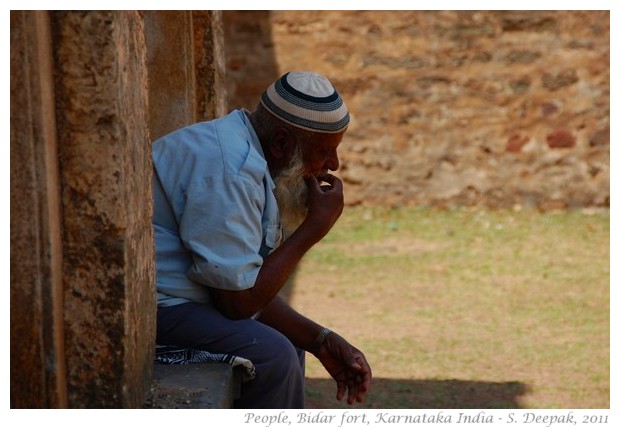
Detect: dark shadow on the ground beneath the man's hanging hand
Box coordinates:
(306, 378, 528, 409)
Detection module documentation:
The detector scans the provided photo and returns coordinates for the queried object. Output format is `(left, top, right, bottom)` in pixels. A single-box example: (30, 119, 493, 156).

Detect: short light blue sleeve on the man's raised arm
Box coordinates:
(179, 174, 265, 290)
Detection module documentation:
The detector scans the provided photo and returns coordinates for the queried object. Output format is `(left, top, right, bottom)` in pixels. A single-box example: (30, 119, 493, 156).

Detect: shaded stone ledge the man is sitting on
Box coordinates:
(143, 363, 240, 409)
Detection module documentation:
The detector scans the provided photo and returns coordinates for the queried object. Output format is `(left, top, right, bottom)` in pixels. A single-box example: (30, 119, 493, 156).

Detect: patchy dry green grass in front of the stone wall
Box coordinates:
(291, 207, 610, 408)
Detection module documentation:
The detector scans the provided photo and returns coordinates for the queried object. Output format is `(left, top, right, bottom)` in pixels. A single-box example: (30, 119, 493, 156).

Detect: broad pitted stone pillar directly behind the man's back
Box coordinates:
(52, 11, 155, 408)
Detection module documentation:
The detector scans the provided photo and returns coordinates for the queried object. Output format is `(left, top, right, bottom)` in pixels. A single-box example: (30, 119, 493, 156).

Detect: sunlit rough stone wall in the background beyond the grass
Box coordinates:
(224, 11, 610, 209)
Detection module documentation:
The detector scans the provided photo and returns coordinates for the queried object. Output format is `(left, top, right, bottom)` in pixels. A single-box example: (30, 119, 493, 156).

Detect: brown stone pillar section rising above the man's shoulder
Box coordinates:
(144, 11, 227, 140)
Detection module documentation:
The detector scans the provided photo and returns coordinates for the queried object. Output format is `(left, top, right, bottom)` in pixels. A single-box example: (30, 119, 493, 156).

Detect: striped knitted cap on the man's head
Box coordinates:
(260, 71, 349, 133)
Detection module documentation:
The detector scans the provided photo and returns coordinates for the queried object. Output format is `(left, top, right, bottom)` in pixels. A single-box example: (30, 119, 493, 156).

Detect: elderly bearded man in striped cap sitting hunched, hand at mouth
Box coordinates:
(153, 72, 371, 408)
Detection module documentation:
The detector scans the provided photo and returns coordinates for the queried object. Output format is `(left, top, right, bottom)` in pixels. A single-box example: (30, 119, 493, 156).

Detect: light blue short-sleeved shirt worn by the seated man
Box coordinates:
(153, 110, 282, 306)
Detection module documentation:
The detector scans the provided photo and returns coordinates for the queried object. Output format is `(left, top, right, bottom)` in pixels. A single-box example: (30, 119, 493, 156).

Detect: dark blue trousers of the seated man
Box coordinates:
(156, 302, 305, 409)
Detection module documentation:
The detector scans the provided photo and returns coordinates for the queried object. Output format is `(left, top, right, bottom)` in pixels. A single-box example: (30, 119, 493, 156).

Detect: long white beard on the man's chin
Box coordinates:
(274, 153, 308, 239)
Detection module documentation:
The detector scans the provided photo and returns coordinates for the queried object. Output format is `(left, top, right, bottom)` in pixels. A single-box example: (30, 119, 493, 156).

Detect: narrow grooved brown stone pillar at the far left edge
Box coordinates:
(11, 11, 67, 408)
